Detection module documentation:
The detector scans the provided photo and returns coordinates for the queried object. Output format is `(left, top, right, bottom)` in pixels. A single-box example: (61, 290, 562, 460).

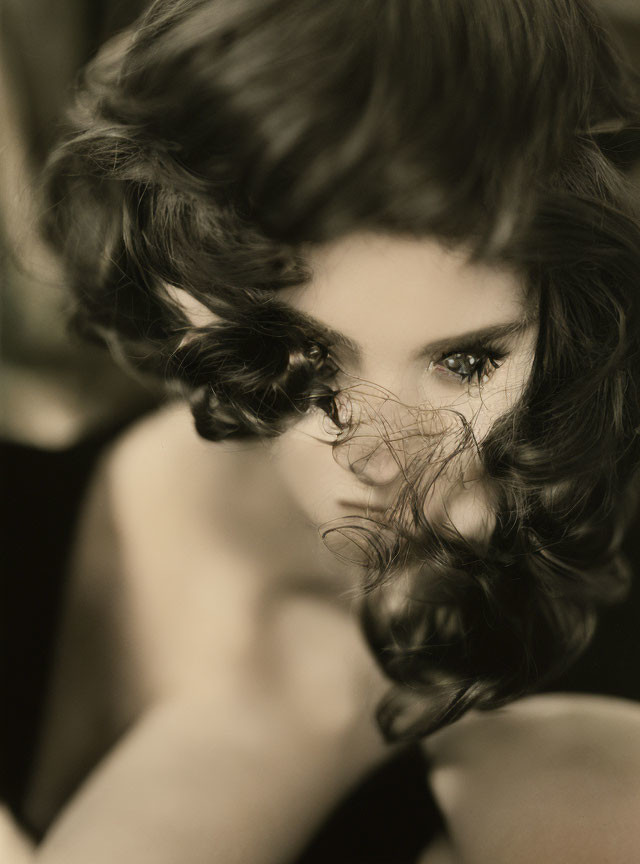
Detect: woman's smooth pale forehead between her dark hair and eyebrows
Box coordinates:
(279, 234, 526, 354)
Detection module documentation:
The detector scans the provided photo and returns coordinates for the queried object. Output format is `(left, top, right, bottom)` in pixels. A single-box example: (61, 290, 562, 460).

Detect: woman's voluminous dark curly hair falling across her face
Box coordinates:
(45, 0, 640, 738)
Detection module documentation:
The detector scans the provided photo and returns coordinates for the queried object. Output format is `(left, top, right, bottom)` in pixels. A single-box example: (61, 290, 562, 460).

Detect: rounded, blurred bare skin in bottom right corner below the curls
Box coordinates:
(425, 694, 640, 864)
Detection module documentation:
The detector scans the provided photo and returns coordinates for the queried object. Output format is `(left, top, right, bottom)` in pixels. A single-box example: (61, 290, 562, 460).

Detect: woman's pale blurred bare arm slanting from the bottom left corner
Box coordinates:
(35, 607, 396, 864)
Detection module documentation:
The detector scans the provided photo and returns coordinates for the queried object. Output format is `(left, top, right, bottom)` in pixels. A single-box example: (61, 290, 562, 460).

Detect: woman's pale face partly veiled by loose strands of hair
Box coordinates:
(269, 233, 537, 530)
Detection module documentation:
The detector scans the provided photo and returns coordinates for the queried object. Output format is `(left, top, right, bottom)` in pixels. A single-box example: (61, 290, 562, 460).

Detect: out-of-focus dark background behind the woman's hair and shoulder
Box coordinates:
(0, 0, 640, 861)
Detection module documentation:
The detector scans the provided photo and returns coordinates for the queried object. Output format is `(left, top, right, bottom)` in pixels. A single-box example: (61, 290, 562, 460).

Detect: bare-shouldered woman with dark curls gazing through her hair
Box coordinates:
(6, 0, 640, 864)
